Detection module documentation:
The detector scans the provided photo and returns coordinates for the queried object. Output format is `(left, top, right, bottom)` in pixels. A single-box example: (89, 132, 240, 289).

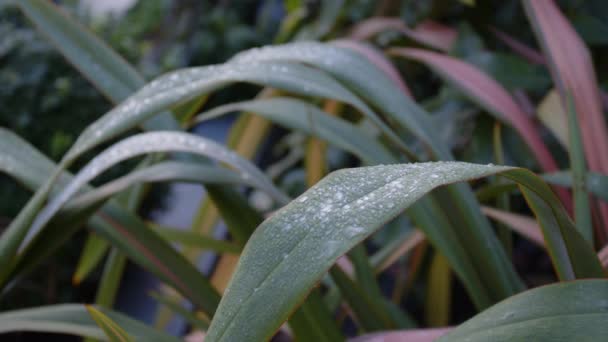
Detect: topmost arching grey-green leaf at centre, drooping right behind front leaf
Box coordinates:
(234, 41, 523, 302)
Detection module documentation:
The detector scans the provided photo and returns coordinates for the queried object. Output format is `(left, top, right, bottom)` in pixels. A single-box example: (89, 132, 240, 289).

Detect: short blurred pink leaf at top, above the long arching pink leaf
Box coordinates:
(351, 17, 458, 51)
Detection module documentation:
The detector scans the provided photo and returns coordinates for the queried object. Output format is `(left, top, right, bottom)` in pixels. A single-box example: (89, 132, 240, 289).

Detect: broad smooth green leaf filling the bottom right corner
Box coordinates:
(439, 279, 608, 342)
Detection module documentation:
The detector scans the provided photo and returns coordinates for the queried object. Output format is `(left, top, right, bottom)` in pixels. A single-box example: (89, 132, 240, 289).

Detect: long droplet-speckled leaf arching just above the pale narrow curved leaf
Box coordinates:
(64, 61, 400, 161)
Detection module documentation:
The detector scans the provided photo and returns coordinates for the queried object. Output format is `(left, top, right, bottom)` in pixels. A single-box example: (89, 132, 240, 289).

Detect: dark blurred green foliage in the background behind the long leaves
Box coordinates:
(0, 0, 608, 334)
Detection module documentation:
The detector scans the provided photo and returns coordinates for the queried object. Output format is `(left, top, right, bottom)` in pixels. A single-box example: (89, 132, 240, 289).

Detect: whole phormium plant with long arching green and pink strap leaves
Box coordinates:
(0, 0, 608, 341)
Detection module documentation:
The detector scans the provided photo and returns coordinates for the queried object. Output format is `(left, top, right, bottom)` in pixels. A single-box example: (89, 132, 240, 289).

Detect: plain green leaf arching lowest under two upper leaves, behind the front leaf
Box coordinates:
(194, 98, 498, 308)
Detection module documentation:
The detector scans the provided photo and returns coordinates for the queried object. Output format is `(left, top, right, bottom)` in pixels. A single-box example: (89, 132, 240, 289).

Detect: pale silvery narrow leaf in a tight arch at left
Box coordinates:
(25, 132, 287, 248)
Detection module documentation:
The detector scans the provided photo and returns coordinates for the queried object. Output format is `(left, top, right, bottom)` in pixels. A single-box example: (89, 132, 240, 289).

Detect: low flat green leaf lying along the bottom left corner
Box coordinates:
(0, 304, 178, 342)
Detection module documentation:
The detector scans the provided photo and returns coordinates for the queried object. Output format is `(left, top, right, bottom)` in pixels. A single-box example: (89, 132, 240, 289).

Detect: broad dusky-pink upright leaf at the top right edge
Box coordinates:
(524, 0, 608, 238)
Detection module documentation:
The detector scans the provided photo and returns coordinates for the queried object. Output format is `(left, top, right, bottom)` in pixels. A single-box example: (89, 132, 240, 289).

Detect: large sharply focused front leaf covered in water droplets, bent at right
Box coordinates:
(206, 162, 603, 342)
